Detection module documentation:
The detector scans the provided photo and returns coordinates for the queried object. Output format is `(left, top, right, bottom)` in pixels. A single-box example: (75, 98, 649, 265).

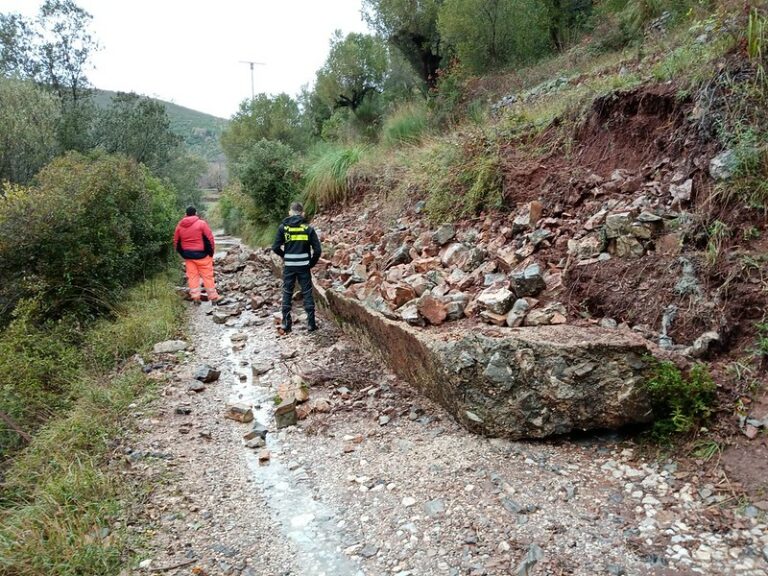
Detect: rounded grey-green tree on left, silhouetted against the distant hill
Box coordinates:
(94, 92, 181, 172)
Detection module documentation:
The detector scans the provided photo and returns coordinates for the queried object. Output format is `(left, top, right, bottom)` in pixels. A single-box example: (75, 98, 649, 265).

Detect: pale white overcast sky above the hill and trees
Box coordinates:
(0, 0, 366, 118)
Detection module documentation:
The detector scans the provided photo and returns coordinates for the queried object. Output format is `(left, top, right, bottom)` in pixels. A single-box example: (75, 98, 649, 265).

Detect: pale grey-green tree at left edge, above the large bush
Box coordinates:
(0, 76, 60, 184)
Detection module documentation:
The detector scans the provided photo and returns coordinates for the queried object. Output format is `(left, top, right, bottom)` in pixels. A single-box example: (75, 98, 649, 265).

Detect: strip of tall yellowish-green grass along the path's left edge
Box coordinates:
(0, 277, 183, 576)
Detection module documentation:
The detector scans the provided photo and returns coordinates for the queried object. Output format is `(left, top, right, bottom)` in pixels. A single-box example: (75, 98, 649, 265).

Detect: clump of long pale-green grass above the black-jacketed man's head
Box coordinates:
(304, 145, 366, 213)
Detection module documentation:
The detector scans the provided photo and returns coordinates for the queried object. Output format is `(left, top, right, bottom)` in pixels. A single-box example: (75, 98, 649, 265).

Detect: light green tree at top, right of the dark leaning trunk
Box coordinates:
(432, 0, 549, 73)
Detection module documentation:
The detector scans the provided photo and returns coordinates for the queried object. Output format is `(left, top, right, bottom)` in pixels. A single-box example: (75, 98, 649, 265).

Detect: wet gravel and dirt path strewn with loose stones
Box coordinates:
(127, 236, 768, 576)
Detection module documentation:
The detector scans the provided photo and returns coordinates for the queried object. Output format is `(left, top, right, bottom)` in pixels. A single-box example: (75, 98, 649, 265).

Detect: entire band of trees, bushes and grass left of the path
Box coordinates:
(0, 0, 190, 576)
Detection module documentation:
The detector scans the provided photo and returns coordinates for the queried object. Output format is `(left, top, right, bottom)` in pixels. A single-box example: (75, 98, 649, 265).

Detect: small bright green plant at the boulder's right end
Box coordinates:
(645, 361, 716, 440)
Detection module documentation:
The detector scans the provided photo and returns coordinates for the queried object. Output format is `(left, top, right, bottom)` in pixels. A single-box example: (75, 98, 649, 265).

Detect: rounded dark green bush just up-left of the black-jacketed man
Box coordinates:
(235, 140, 299, 225)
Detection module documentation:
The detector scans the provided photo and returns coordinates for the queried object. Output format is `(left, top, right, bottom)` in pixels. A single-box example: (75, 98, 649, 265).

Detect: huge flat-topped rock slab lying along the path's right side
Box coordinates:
(318, 291, 651, 438)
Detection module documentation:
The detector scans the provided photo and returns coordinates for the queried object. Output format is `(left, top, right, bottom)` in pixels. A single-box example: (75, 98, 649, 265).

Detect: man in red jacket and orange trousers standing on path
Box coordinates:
(173, 206, 219, 306)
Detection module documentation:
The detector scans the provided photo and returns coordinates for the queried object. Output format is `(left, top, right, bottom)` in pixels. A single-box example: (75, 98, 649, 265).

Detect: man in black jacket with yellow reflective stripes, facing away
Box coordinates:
(272, 202, 322, 332)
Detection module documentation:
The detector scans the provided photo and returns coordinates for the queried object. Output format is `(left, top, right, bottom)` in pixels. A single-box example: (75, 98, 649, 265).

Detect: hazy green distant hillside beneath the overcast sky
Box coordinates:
(93, 90, 227, 162)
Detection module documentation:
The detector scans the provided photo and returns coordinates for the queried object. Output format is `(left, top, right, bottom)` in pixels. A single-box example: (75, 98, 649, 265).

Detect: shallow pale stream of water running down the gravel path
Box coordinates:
(221, 311, 365, 576)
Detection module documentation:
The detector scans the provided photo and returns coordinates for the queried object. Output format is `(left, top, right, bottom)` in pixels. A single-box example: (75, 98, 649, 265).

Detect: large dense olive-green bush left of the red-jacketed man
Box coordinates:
(0, 153, 177, 317)
